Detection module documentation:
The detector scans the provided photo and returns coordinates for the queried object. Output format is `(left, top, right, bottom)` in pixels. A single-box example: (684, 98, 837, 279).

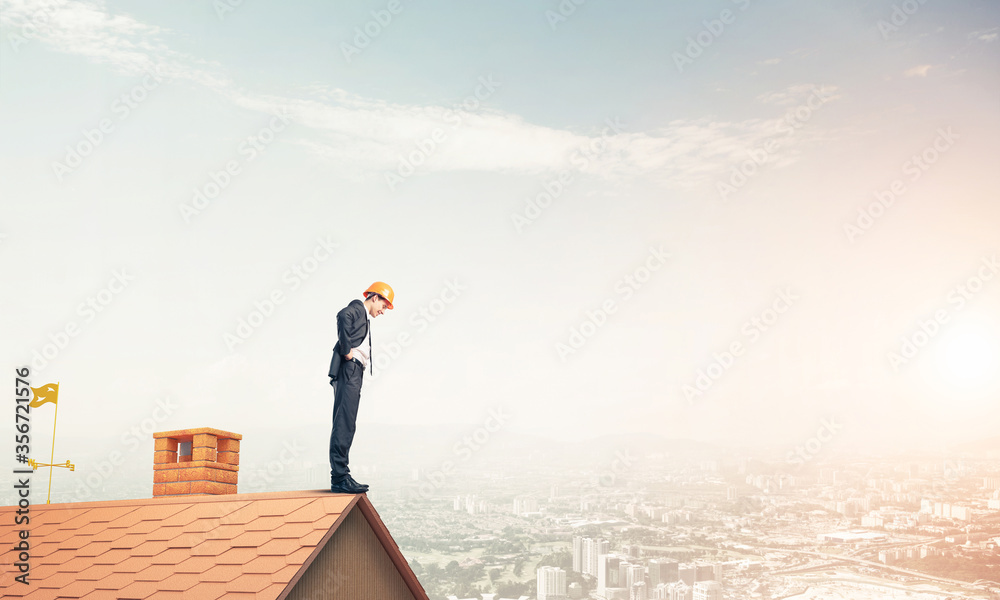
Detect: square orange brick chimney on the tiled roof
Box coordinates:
(153, 427, 243, 497)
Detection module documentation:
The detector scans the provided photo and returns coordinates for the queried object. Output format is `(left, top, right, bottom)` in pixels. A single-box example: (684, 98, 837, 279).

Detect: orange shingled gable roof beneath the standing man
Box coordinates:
(0, 490, 426, 600)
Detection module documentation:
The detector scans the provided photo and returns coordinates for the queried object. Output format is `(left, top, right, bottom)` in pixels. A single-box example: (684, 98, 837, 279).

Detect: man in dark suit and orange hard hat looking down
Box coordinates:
(330, 281, 395, 494)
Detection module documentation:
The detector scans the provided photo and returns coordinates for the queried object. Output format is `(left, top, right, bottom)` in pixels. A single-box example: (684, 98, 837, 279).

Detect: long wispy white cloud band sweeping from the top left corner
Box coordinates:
(0, 0, 836, 187)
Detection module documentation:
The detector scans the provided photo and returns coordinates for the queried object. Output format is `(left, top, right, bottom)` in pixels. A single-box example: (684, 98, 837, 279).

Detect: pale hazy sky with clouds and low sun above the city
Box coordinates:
(0, 0, 1000, 500)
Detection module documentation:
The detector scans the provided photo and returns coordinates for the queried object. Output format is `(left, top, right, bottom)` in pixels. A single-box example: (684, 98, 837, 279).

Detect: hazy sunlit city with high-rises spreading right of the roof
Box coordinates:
(375, 434, 1000, 600)
